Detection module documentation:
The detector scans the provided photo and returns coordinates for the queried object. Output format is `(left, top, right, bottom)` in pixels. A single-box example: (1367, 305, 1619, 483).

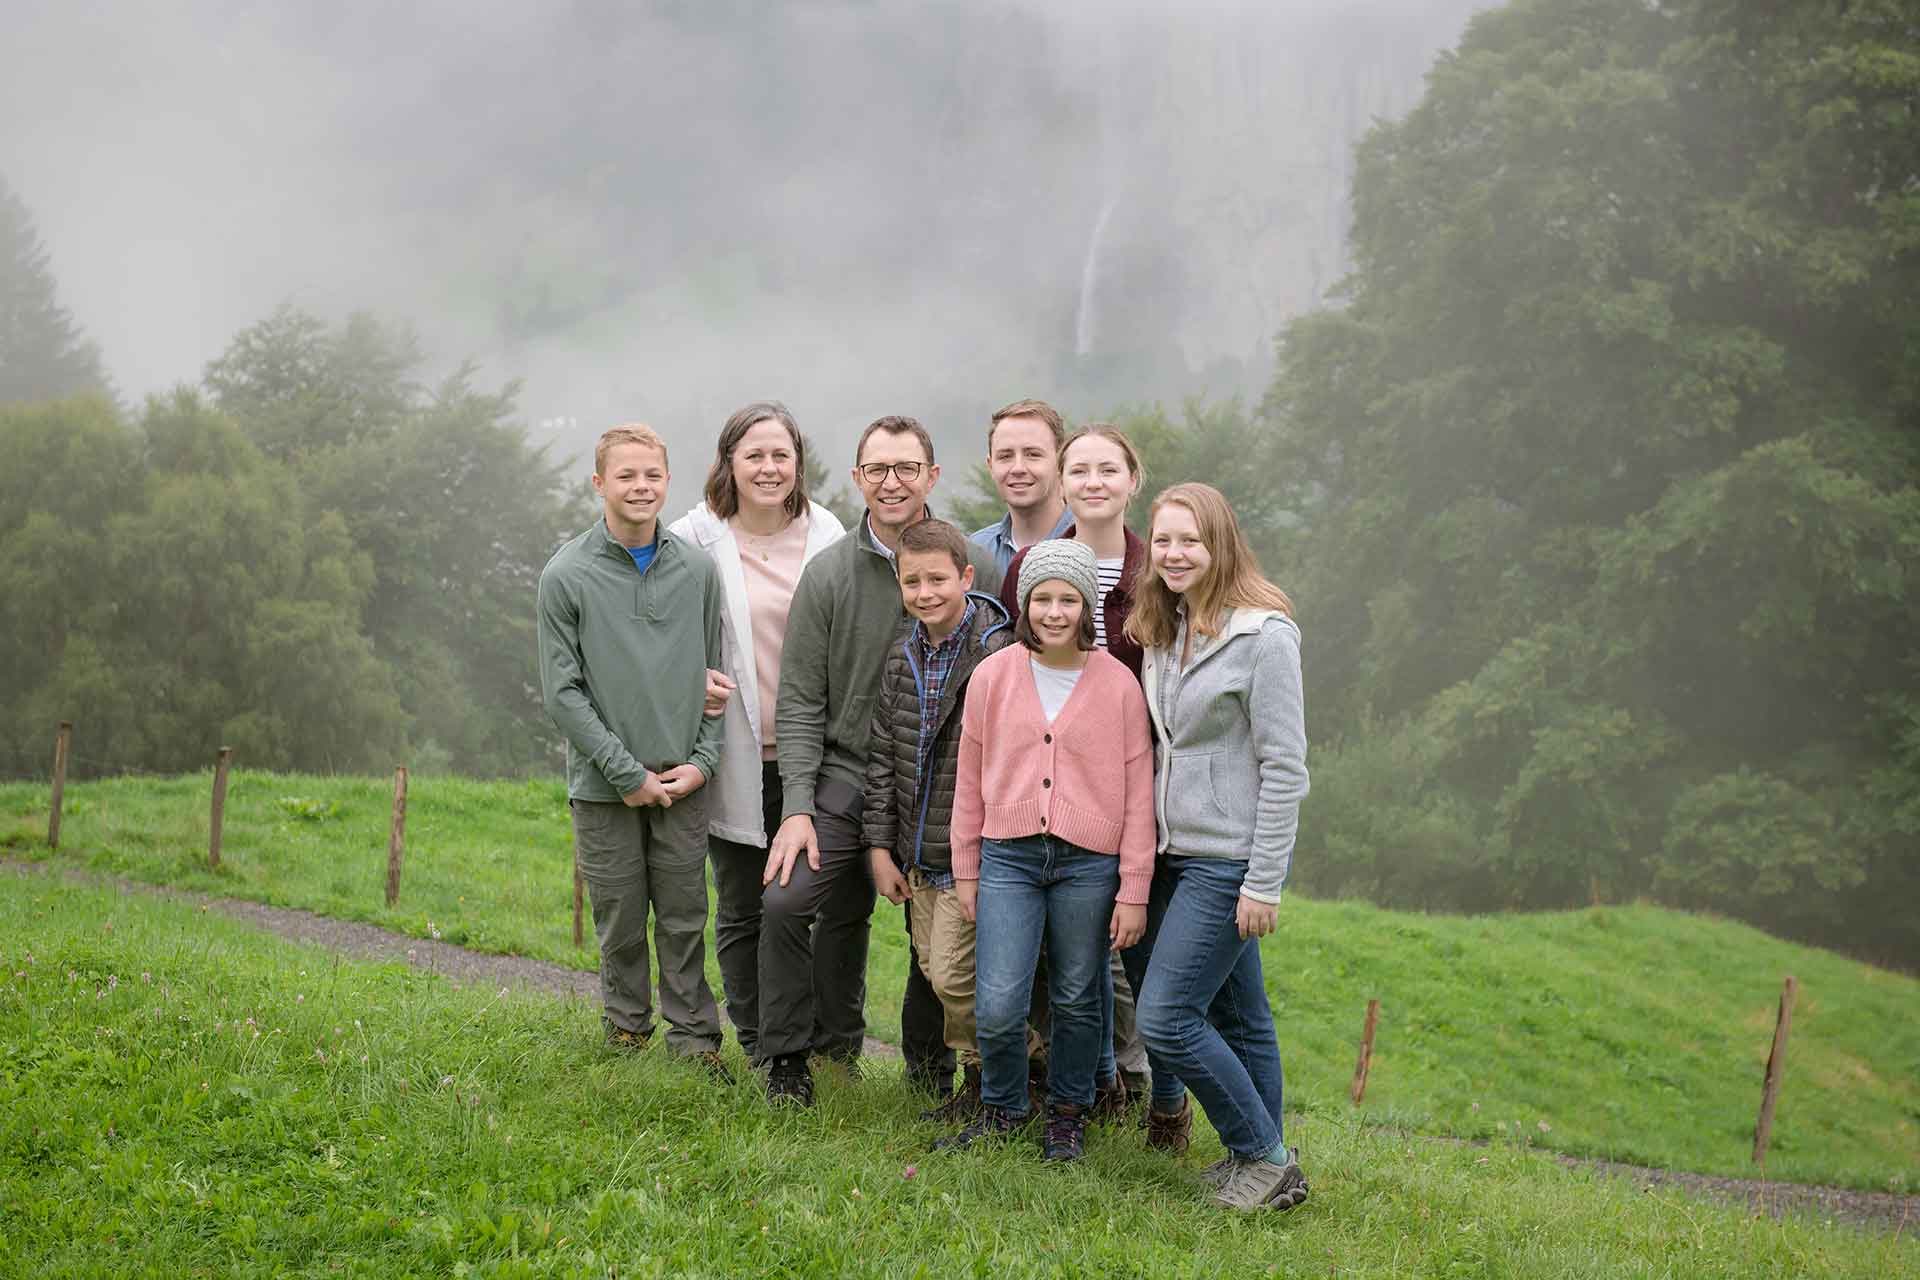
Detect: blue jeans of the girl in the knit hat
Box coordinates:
(973, 835, 1119, 1115)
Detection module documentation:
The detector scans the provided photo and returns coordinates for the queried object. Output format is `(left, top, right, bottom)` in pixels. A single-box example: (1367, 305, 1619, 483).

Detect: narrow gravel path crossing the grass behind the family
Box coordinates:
(0, 860, 1920, 1234)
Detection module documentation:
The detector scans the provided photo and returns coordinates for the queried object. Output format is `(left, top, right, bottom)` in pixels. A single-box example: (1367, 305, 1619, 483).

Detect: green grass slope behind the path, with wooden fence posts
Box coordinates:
(0, 773, 1920, 1192)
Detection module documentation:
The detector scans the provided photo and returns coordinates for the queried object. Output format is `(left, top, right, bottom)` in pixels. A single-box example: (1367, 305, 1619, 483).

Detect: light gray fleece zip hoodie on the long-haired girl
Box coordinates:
(1140, 608, 1308, 902)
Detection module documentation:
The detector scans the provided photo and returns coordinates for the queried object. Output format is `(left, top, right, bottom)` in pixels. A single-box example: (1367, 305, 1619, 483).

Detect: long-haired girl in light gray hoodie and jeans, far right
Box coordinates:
(1127, 484, 1308, 1211)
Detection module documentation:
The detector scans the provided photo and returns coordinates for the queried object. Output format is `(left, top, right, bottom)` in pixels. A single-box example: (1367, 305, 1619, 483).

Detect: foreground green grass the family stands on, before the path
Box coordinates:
(0, 875, 1920, 1276)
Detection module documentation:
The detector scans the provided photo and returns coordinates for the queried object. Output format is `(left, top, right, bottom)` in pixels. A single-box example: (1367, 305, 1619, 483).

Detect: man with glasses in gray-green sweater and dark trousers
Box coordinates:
(760, 416, 1000, 1105)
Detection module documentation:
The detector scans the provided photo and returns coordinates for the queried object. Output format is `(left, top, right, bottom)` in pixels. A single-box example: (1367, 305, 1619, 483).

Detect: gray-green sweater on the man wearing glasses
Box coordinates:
(774, 512, 1000, 818)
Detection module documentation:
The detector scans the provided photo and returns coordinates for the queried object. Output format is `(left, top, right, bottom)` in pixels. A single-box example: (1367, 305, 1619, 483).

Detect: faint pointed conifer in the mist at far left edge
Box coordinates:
(0, 178, 109, 403)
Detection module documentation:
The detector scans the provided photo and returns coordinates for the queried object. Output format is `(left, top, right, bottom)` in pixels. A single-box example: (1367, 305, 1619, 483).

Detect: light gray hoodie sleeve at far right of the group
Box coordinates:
(1240, 618, 1308, 902)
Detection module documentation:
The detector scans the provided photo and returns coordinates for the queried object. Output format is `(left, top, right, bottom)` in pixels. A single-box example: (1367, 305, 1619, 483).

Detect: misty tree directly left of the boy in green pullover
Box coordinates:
(205, 307, 589, 773)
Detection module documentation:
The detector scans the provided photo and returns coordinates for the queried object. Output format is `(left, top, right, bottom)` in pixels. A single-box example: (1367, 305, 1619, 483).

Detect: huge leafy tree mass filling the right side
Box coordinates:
(1258, 0, 1920, 958)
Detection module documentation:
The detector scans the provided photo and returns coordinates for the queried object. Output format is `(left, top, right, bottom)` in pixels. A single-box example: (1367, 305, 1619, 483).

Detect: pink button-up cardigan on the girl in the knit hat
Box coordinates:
(952, 645, 1158, 904)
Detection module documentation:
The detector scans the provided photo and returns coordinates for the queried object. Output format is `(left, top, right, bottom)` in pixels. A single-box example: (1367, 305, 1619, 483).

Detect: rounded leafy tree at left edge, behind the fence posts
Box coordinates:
(0, 391, 403, 773)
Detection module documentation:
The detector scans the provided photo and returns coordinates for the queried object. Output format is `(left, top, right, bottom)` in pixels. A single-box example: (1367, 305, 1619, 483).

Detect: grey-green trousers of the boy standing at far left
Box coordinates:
(570, 793, 720, 1054)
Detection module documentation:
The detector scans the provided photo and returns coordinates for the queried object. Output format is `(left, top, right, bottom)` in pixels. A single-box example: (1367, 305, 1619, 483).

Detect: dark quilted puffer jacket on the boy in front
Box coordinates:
(860, 591, 1014, 873)
